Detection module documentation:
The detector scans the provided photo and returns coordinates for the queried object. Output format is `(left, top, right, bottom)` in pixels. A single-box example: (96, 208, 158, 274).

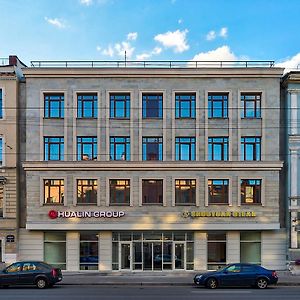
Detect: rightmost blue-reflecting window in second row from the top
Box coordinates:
(241, 137, 261, 160)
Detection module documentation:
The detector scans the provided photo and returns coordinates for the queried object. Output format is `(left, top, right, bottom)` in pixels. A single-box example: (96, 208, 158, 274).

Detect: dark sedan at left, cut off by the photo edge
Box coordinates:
(0, 261, 62, 289)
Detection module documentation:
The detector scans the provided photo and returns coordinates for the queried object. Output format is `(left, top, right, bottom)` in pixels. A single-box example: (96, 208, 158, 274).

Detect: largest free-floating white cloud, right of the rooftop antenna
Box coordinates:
(154, 29, 190, 53)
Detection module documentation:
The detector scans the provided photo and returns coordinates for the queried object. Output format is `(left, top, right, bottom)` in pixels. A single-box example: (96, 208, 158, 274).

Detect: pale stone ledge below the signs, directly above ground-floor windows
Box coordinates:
(26, 222, 280, 231)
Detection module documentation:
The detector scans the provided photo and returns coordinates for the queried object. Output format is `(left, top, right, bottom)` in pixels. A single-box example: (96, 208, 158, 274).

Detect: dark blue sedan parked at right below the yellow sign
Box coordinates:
(194, 263, 278, 289)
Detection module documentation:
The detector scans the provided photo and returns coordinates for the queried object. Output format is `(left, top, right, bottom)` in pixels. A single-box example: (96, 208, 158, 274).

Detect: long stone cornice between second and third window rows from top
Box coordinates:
(23, 161, 283, 171)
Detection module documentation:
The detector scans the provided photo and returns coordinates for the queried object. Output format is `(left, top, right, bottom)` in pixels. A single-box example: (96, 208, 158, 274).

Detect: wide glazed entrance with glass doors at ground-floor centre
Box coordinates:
(112, 231, 194, 271)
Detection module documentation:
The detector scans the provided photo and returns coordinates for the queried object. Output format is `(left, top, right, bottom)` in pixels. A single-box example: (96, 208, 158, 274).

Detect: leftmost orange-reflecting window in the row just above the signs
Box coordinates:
(44, 179, 64, 204)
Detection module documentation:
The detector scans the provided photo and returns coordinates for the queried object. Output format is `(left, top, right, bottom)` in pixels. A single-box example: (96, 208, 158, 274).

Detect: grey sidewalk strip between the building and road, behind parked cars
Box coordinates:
(58, 271, 300, 286)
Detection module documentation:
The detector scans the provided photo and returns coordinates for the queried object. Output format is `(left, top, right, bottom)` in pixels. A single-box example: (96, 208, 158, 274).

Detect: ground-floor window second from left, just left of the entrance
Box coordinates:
(80, 232, 99, 270)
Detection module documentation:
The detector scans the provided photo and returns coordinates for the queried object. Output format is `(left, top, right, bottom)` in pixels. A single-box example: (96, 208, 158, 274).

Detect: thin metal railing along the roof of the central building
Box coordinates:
(31, 60, 275, 69)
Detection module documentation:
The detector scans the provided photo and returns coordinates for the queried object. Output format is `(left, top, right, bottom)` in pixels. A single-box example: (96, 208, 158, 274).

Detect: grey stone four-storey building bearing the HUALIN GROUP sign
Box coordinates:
(20, 62, 286, 271)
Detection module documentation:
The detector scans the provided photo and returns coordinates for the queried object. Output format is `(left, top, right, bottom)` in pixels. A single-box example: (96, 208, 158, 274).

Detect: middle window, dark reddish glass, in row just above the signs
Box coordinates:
(142, 179, 163, 204)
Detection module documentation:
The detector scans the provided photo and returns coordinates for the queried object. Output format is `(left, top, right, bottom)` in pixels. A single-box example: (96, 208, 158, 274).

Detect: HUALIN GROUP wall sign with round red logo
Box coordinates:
(48, 210, 125, 219)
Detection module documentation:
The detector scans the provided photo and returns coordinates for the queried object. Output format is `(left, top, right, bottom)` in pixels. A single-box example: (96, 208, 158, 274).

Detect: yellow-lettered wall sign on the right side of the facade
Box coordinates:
(182, 211, 256, 218)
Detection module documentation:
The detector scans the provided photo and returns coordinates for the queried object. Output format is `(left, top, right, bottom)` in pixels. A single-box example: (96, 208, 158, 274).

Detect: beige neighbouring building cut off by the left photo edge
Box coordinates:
(0, 56, 25, 263)
